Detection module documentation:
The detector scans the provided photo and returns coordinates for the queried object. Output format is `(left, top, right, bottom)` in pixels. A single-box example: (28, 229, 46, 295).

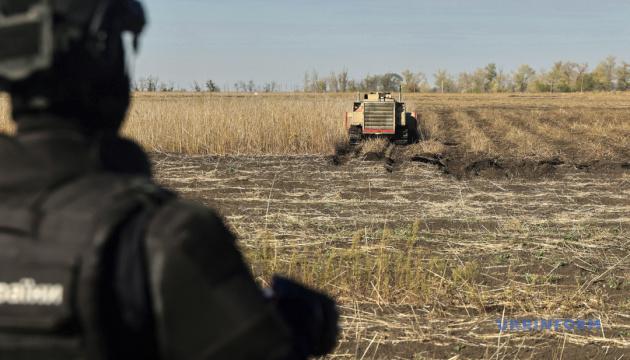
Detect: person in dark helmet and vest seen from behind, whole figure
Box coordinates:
(0, 0, 338, 360)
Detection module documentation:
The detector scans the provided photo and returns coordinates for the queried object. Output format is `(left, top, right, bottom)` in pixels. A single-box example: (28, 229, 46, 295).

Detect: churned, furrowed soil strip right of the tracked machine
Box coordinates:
(408, 100, 630, 179)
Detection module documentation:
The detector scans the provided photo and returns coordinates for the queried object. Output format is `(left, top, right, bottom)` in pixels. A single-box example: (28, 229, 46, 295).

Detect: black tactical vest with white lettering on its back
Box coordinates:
(0, 174, 166, 360)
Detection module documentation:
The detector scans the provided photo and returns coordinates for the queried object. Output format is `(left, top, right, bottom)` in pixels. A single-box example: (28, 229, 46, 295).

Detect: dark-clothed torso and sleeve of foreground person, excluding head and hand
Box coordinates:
(0, 131, 293, 360)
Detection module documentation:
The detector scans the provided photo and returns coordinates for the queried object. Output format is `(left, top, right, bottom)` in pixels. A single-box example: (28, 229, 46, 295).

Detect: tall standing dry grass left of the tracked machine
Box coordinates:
(124, 94, 351, 155)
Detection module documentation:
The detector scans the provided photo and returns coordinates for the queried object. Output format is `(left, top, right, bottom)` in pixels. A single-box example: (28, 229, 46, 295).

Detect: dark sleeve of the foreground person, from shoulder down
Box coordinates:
(146, 201, 293, 360)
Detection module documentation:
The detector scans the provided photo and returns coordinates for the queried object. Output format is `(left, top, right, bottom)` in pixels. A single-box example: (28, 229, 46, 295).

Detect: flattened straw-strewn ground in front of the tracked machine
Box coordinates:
(154, 154, 630, 359)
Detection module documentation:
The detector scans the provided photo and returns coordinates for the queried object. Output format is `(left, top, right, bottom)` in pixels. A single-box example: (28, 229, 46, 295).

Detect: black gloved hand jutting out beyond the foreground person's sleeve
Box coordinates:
(271, 276, 339, 356)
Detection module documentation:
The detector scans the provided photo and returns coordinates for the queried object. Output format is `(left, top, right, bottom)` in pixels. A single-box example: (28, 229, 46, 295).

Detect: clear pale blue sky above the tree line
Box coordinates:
(135, 0, 630, 88)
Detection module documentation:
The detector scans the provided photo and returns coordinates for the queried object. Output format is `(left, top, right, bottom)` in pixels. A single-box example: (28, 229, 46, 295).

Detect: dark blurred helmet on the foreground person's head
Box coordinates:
(0, 0, 146, 81)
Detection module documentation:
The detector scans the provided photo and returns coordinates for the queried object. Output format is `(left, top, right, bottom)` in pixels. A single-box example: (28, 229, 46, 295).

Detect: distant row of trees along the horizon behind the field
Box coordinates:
(132, 56, 630, 93)
